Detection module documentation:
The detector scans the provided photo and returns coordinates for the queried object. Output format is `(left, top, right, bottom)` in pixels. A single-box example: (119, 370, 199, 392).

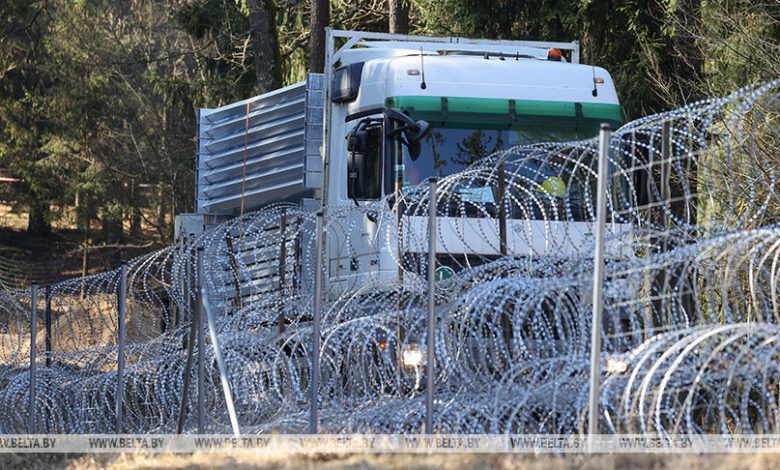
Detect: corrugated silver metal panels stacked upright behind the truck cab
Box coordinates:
(196, 74, 324, 215)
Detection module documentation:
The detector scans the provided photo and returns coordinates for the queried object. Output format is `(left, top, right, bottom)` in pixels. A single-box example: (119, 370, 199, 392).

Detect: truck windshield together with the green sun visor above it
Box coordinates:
(385, 96, 625, 221)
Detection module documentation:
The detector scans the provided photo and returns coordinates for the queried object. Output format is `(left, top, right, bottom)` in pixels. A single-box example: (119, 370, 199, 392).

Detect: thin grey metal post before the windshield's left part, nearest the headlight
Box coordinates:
(425, 179, 436, 434)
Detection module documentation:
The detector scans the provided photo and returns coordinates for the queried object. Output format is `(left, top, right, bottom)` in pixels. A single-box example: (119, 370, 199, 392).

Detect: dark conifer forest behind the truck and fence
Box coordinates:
(0, 0, 780, 286)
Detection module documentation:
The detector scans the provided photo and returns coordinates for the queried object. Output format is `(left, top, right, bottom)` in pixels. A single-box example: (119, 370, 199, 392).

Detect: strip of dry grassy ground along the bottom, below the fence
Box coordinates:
(0, 452, 780, 470)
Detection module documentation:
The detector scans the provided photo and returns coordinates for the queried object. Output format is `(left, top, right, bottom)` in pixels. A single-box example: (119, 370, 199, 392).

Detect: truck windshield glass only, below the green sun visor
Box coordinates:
(395, 127, 629, 221)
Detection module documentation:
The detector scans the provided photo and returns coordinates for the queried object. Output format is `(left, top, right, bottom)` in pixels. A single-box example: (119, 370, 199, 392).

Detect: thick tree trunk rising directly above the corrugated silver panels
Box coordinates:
(246, 0, 282, 93)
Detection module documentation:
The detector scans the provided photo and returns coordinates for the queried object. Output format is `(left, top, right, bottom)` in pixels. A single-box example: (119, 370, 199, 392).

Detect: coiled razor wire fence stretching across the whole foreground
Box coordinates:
(0, 81, 780, 435)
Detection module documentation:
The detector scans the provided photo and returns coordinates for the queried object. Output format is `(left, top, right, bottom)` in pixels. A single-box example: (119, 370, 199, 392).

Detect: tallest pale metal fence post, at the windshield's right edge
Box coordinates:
(588, 124, 612, 452)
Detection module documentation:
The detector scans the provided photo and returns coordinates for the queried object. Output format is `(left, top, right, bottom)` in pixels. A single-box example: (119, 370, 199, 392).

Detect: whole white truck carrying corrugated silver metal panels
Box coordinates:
(184, 29, 631, 302)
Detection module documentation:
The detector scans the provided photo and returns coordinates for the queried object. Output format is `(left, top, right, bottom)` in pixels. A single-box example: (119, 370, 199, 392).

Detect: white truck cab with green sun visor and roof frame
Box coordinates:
(322, 32, 631, 288)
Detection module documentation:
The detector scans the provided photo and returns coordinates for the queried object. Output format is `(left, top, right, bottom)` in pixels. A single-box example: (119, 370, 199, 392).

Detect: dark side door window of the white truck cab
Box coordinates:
(347, 119, 382, 201)
